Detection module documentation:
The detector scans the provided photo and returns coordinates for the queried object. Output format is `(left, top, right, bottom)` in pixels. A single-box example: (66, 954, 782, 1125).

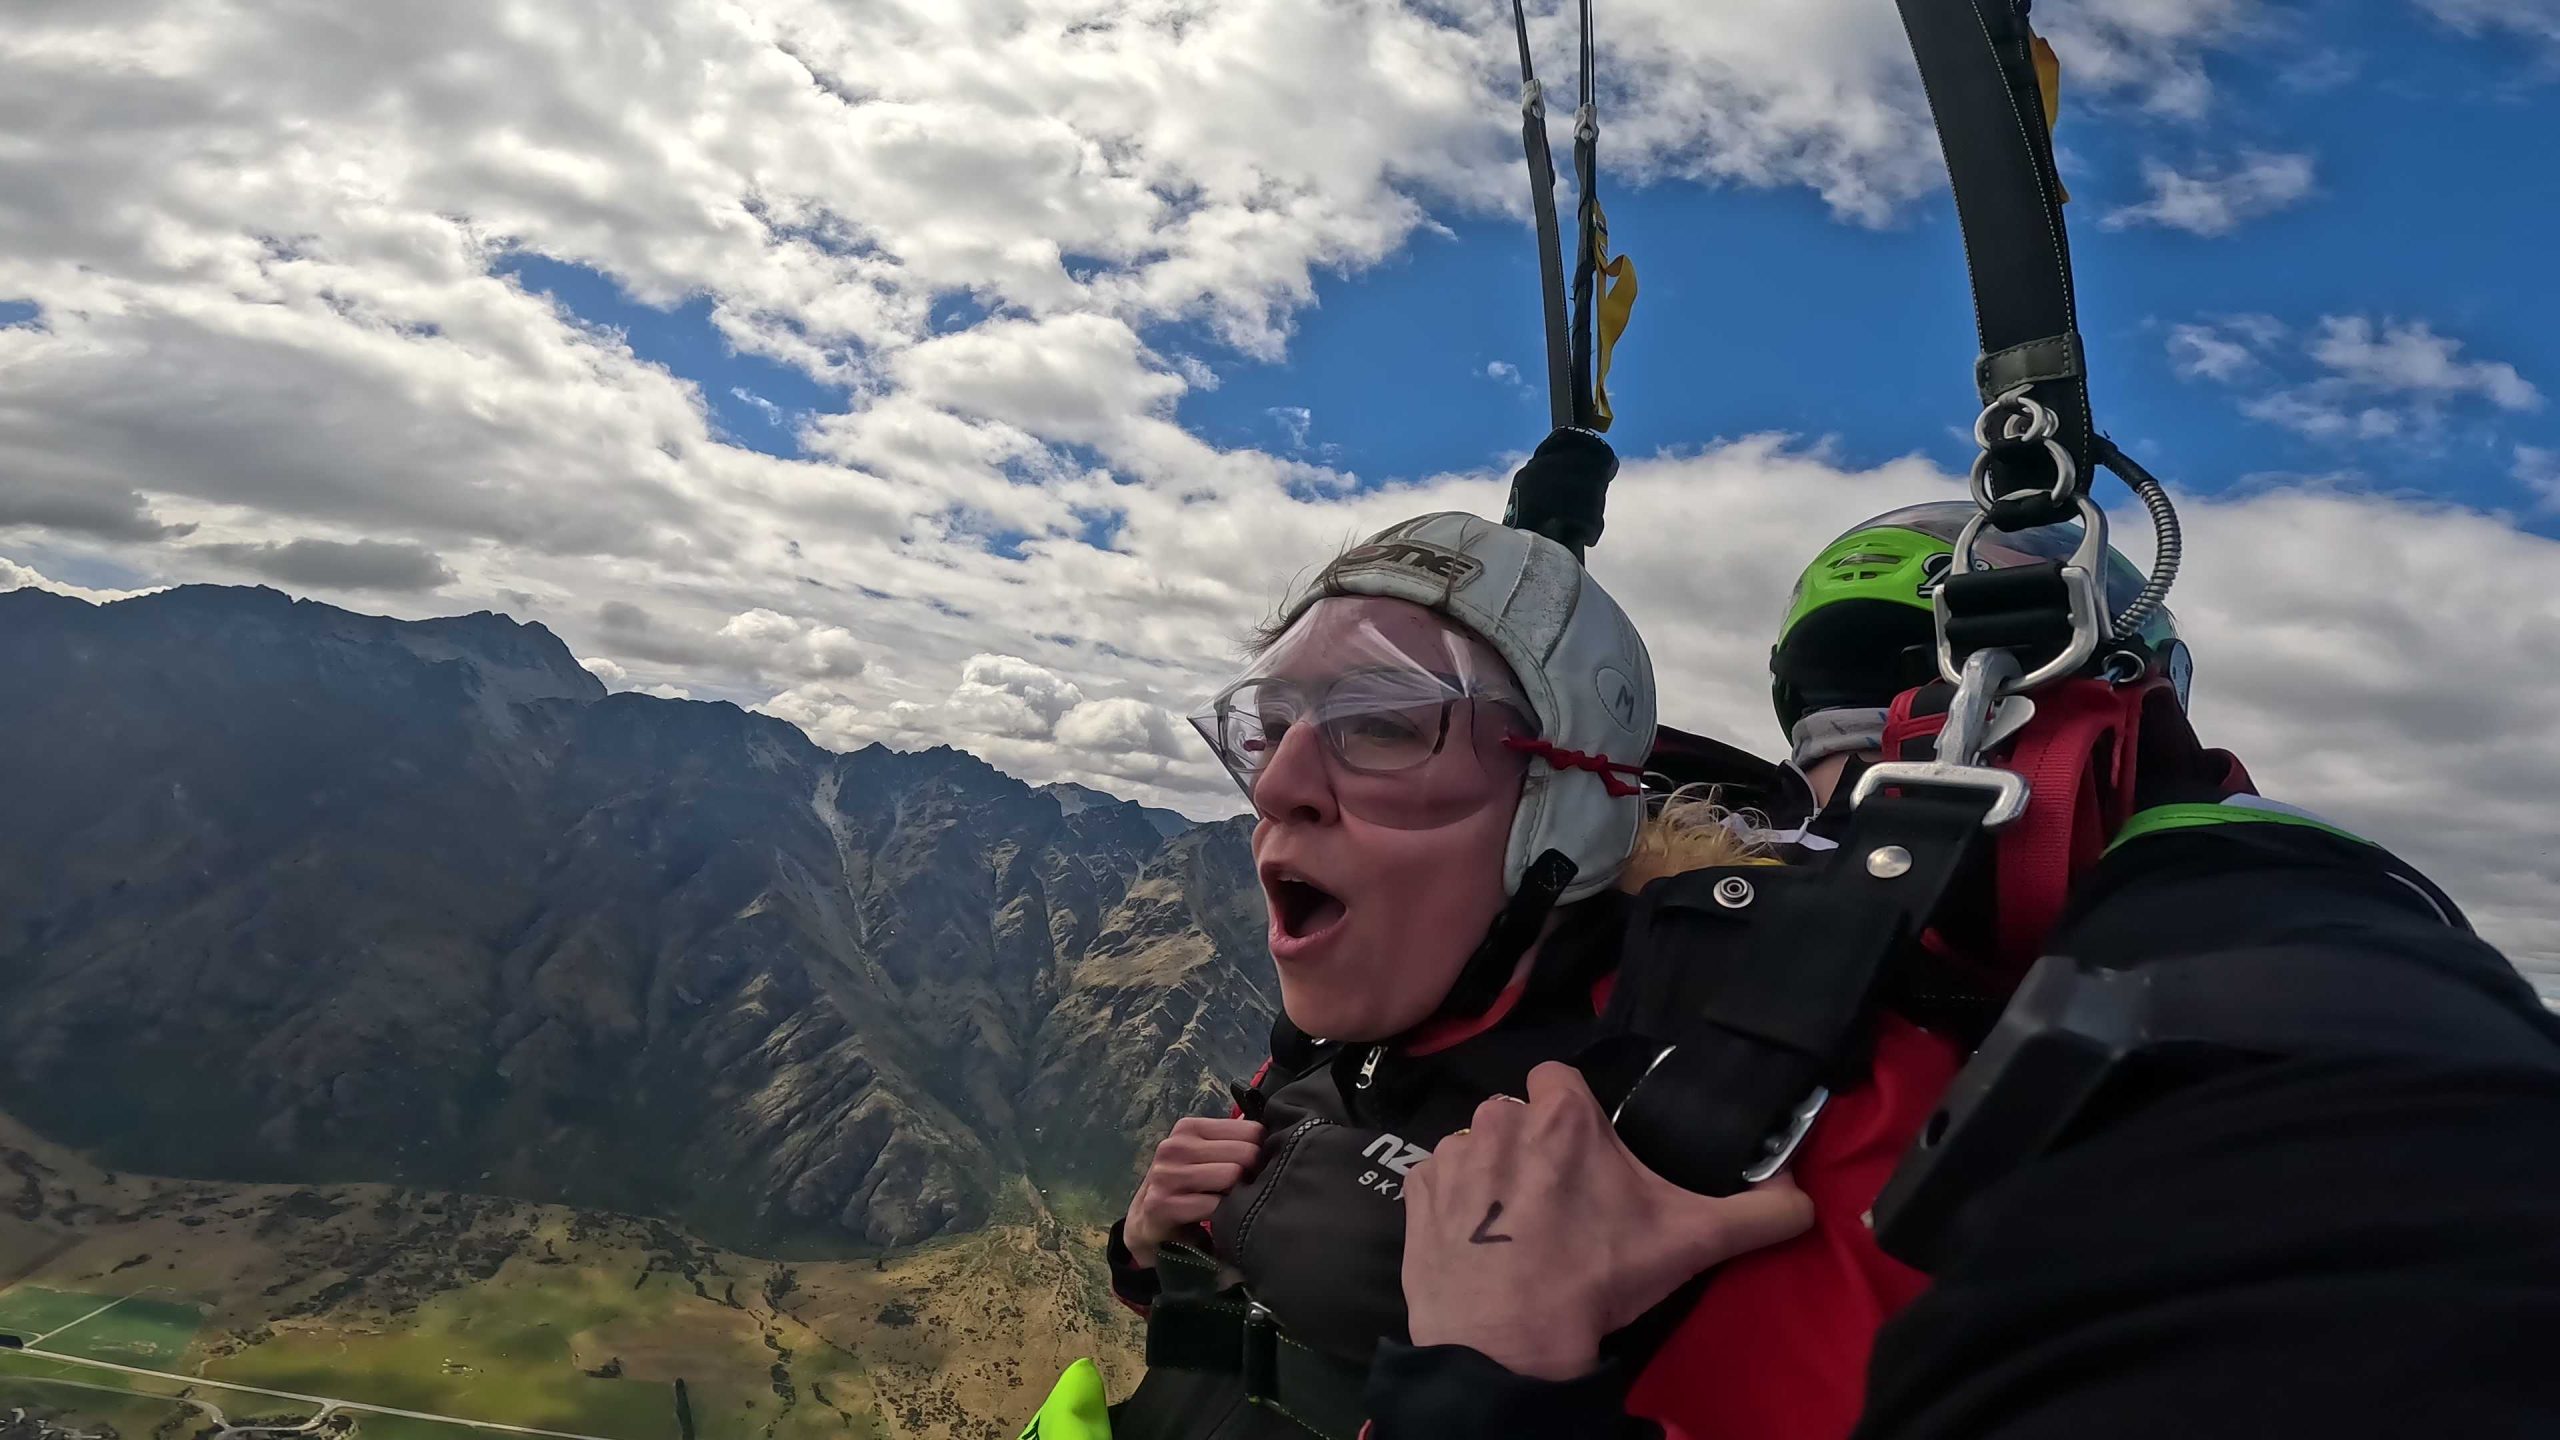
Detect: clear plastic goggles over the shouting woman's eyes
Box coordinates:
(1190, 597, 1539, 830)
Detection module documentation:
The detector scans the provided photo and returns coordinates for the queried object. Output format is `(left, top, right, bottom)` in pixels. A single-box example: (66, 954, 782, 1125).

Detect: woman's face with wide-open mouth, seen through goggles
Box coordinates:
(1252, 597, 1528, 1040)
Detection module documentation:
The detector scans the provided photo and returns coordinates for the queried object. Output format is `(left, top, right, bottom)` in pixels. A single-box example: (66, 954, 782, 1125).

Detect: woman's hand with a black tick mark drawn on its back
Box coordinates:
(1405, 1061, 1812, 1381)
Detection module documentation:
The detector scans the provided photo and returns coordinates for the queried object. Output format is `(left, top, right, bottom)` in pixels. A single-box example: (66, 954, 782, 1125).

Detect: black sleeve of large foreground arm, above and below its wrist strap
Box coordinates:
(1856, 828, 2560, 1440)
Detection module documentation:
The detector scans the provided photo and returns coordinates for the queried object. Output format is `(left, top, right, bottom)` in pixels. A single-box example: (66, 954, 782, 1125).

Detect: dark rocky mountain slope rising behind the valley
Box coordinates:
(0, 587, 1275, 1245)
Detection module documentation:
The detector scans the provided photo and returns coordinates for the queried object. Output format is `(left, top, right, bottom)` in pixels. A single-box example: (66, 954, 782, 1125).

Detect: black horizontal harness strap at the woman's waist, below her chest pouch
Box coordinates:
(1147, 1245, 1370, 1440)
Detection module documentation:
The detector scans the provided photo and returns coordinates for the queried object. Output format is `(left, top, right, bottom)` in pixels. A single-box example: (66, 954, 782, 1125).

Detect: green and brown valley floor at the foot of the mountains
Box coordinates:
(0, 1120, 1139, 1440)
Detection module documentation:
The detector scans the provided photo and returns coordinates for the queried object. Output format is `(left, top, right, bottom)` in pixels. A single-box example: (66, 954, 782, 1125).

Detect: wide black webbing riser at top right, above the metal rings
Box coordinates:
(1897, 0, 2092, 517)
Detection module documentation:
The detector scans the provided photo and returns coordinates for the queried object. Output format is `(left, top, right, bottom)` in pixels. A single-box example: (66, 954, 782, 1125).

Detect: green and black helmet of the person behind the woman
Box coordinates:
(1769, 500, 2186, 733)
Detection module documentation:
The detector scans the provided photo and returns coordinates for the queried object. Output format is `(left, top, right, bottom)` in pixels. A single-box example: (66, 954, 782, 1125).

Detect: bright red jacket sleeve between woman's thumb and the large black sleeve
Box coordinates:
(1628, 1015, 1961, 1440)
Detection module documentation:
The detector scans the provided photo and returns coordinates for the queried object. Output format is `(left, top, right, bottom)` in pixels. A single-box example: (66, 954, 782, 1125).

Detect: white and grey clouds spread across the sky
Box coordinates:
(0, 0, 2560, 999)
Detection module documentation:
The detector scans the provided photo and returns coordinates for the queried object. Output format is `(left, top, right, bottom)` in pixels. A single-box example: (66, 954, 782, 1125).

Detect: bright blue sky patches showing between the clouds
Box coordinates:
(476, 5, 2560, 536)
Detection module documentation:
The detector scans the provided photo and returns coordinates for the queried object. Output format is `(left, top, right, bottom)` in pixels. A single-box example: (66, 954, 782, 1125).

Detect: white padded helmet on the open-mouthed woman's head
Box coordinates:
(1288, 510, 1654, 902)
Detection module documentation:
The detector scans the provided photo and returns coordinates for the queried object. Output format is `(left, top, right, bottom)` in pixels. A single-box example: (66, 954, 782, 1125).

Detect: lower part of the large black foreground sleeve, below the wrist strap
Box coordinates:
(1856, 1061, 2560, 1440)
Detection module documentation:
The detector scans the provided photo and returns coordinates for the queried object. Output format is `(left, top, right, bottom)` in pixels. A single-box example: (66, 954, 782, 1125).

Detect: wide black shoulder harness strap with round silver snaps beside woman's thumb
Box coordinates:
(1577, 792, 1987, 1194)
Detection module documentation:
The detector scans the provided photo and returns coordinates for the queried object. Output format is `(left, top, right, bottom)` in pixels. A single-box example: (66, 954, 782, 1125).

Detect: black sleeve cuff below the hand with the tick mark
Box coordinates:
(1364, 1340, 1661, 1440)
